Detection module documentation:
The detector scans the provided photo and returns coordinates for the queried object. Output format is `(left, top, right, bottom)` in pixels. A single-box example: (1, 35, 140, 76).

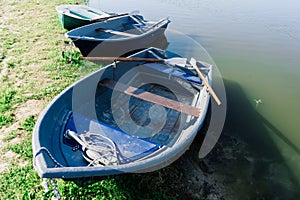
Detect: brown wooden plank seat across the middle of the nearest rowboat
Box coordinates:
(99, 79, 200, 117)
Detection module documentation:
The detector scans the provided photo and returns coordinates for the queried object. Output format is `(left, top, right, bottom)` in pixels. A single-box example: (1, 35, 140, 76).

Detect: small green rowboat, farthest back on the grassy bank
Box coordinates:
(56, 4, 113, 30)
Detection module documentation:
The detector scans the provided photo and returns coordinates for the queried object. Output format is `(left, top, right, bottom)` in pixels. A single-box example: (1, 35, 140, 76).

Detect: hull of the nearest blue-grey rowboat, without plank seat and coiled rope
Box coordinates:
(32, 48, 211, 179)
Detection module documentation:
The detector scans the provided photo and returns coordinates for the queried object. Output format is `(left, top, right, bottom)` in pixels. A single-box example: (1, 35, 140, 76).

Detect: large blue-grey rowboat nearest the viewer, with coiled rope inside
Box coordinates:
(32, 48, 212, 179)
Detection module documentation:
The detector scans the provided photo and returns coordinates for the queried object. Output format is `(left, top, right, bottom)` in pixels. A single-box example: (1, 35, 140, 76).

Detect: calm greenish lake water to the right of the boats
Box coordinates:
(90, 0, 300, 199)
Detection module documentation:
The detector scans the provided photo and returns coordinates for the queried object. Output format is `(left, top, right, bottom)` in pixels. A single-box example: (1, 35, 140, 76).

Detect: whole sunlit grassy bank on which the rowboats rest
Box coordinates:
(0, 0, 186, 199)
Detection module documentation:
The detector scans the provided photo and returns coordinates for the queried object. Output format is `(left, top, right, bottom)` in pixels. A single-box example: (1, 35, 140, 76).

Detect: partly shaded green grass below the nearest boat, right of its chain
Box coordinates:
(58, 167, 180, 199)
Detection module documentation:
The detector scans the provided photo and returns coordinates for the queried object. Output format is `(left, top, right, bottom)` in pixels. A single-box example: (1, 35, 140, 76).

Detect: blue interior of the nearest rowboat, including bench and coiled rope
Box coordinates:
(34, 48, 203, 167)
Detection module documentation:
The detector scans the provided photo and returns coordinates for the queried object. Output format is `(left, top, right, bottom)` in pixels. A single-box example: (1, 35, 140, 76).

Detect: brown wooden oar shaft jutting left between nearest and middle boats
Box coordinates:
(79, 57, 165, 62)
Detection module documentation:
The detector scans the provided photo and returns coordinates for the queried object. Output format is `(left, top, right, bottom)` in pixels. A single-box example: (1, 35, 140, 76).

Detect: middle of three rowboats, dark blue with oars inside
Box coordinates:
(66, 14, 170, 57)
